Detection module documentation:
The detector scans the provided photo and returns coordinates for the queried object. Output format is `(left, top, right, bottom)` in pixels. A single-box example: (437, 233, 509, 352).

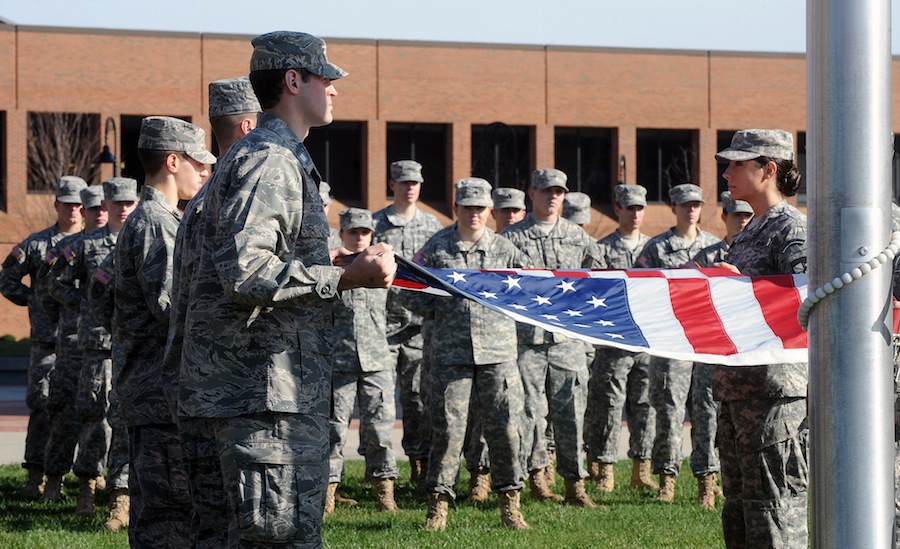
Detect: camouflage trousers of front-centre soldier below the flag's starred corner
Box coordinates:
(425, 361, 525, 498)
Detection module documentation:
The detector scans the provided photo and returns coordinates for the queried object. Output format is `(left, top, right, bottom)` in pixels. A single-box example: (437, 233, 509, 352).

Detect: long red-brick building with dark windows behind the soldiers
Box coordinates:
(0, 24, 900, 337)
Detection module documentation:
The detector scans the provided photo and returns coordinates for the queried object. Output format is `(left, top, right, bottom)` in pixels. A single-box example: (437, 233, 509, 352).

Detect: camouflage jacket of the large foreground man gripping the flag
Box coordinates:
(178, 114, 342, 417)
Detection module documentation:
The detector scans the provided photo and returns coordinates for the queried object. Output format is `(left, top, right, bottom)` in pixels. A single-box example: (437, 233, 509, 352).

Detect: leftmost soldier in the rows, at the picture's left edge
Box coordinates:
(0, 176, 87, 498)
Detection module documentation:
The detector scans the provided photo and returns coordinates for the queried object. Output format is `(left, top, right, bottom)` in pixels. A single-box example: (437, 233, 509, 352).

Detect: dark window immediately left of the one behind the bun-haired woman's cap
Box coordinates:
(637, 129, 697, 202)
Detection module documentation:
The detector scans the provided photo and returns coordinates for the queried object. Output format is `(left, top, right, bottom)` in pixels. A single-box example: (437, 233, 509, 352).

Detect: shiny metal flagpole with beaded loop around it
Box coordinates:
(806, 0, 894, 548)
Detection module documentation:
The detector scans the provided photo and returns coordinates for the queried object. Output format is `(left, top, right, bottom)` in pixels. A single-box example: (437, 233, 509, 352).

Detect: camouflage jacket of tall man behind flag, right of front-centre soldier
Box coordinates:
(500, 213, 602, 345)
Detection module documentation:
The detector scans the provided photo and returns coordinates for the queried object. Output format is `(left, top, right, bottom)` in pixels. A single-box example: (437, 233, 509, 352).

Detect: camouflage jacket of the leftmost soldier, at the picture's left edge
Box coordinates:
(0, 225, 68, 344)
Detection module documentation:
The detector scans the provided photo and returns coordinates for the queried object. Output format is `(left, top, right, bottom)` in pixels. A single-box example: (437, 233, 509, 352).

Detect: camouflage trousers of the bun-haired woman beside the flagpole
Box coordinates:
(716, 398, 809, 548)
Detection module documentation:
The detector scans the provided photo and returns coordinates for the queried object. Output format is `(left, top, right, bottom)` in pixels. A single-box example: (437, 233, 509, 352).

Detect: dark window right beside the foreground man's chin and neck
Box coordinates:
(303, 122, 365, 203)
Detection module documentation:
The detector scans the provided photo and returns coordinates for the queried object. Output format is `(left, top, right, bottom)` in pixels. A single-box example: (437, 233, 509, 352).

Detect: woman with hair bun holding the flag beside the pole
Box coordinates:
(713, 130, 809, 547)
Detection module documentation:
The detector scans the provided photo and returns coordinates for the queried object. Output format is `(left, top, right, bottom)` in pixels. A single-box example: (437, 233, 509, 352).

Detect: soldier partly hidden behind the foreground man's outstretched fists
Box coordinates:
(320, 206, 397, 515)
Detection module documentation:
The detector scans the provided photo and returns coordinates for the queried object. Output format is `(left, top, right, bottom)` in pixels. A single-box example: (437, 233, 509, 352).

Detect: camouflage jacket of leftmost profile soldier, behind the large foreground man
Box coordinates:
(113, 185, 181, 427)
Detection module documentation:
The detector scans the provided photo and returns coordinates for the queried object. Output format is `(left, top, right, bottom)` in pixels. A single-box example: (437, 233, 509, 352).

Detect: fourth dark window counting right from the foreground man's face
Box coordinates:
(555, 128, 615, 204)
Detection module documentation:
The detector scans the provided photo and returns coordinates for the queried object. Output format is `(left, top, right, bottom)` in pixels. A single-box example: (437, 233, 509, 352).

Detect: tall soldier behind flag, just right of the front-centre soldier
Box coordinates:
(501, 169, 600, 507)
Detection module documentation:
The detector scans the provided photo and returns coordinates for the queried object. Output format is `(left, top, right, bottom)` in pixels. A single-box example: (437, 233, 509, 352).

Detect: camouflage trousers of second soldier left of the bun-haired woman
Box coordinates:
(650, 356, 694, 475)
